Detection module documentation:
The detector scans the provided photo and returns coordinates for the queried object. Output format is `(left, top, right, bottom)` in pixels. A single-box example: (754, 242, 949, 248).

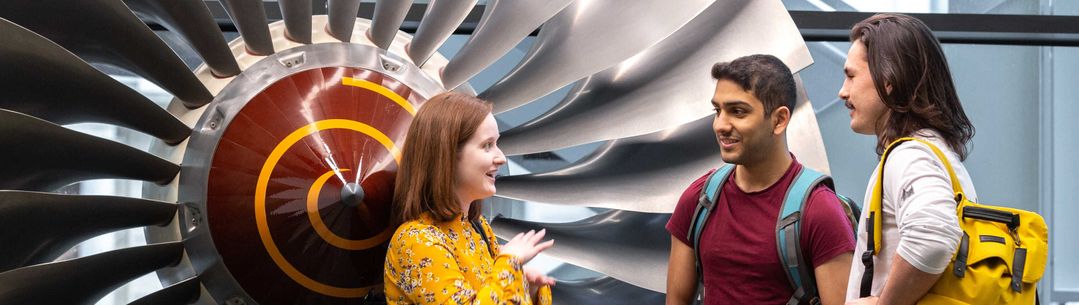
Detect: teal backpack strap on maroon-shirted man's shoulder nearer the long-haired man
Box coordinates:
(776, 167, 832, 305)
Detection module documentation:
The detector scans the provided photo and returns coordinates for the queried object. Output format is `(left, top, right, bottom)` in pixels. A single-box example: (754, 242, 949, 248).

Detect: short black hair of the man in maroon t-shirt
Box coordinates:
(712, 54, 797, 115)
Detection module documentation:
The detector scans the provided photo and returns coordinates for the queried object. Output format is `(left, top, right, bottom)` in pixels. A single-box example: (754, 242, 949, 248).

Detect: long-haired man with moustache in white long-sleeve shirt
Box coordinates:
(839, 14, 978, 304)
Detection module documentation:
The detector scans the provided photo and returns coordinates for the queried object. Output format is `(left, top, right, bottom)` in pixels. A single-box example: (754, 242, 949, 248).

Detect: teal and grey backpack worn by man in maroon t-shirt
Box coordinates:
(686, 164, 861, 305)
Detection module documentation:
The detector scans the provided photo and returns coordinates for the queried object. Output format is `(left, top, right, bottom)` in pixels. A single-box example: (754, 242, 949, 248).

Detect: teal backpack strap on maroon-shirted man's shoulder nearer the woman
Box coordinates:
(686, 164, 735, 300)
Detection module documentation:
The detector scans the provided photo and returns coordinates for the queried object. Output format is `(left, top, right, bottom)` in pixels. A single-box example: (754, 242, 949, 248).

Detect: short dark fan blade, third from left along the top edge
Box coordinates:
(221, 0, 274, 56)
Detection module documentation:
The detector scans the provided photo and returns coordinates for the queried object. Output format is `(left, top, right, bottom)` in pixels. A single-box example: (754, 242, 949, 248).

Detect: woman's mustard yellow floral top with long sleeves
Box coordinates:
(383, 213, 551, 305)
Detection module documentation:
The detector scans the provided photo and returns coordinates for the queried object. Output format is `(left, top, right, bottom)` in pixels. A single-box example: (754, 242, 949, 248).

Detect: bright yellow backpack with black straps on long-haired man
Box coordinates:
(861, 138, 1049, 305)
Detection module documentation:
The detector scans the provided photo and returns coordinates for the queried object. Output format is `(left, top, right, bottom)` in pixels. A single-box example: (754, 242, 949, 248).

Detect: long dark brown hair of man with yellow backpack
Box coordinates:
(850, 14, 974, 160)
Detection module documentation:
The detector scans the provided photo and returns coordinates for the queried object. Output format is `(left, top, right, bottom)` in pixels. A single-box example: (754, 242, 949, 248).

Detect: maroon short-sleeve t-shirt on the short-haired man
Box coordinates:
(667, 160, 855, 305)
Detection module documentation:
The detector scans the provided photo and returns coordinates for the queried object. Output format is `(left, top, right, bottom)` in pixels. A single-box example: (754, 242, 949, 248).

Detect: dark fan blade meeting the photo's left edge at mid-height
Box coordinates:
(0, 109, 180, 191)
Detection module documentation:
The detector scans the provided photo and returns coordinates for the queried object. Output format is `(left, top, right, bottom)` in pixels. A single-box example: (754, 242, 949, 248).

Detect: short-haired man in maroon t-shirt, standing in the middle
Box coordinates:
(667, 55, 855, 305)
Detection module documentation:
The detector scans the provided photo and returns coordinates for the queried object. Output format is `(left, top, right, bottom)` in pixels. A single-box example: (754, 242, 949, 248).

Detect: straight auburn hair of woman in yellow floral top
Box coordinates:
(393, 92, 492, 225)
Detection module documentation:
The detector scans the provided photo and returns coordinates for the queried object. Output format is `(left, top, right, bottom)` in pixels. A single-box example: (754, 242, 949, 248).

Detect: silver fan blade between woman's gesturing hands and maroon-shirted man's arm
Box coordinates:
(491, 211, 673, 293)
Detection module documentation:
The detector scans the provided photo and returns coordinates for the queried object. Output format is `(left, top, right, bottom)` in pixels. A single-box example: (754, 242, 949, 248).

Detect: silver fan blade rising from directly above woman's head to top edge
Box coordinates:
(442, 0, 572, 89)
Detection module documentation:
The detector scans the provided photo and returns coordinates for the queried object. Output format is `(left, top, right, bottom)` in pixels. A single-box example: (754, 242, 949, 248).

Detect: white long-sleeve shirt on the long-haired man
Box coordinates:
(847, 129, 978, 301)
